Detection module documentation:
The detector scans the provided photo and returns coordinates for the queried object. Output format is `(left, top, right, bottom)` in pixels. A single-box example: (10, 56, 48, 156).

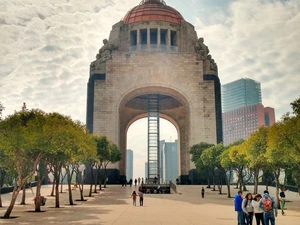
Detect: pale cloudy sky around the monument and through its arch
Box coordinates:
(0, 0, 300, 179)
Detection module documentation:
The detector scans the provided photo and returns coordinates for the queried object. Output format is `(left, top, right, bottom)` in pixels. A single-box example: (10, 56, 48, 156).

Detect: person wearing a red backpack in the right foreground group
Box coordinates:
(259, 190, 278, 225)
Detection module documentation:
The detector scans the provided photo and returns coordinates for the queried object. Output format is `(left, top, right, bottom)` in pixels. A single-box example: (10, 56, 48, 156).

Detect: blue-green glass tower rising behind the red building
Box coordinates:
(222, 78, 261, 112)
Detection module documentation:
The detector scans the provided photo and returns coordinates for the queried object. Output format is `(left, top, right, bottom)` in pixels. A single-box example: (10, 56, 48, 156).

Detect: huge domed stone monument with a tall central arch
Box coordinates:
(87, 0, 222, 183)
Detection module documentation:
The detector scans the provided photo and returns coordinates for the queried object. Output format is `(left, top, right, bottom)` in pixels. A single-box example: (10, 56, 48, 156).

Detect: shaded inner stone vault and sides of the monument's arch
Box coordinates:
(119, 86, 190, 182)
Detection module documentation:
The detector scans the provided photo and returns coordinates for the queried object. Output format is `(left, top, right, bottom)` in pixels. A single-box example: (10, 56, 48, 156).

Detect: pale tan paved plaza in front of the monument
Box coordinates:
(0, 186, 300, 225)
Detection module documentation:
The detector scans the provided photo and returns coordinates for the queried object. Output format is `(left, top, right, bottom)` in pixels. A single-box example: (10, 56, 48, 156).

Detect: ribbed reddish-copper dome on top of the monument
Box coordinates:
(123, 0, 184, 24)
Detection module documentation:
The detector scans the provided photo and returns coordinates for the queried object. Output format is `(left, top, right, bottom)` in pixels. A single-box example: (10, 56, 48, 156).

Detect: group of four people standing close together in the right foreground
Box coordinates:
(234, 190, 285, 225)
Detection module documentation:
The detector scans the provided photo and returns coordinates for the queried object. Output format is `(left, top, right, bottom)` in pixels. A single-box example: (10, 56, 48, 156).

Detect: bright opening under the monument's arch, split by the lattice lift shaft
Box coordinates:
(126, 117, 180, 183)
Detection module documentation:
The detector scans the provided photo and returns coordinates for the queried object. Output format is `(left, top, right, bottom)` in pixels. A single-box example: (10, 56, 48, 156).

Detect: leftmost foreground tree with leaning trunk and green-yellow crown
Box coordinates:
(0, 110, 49, 218)
